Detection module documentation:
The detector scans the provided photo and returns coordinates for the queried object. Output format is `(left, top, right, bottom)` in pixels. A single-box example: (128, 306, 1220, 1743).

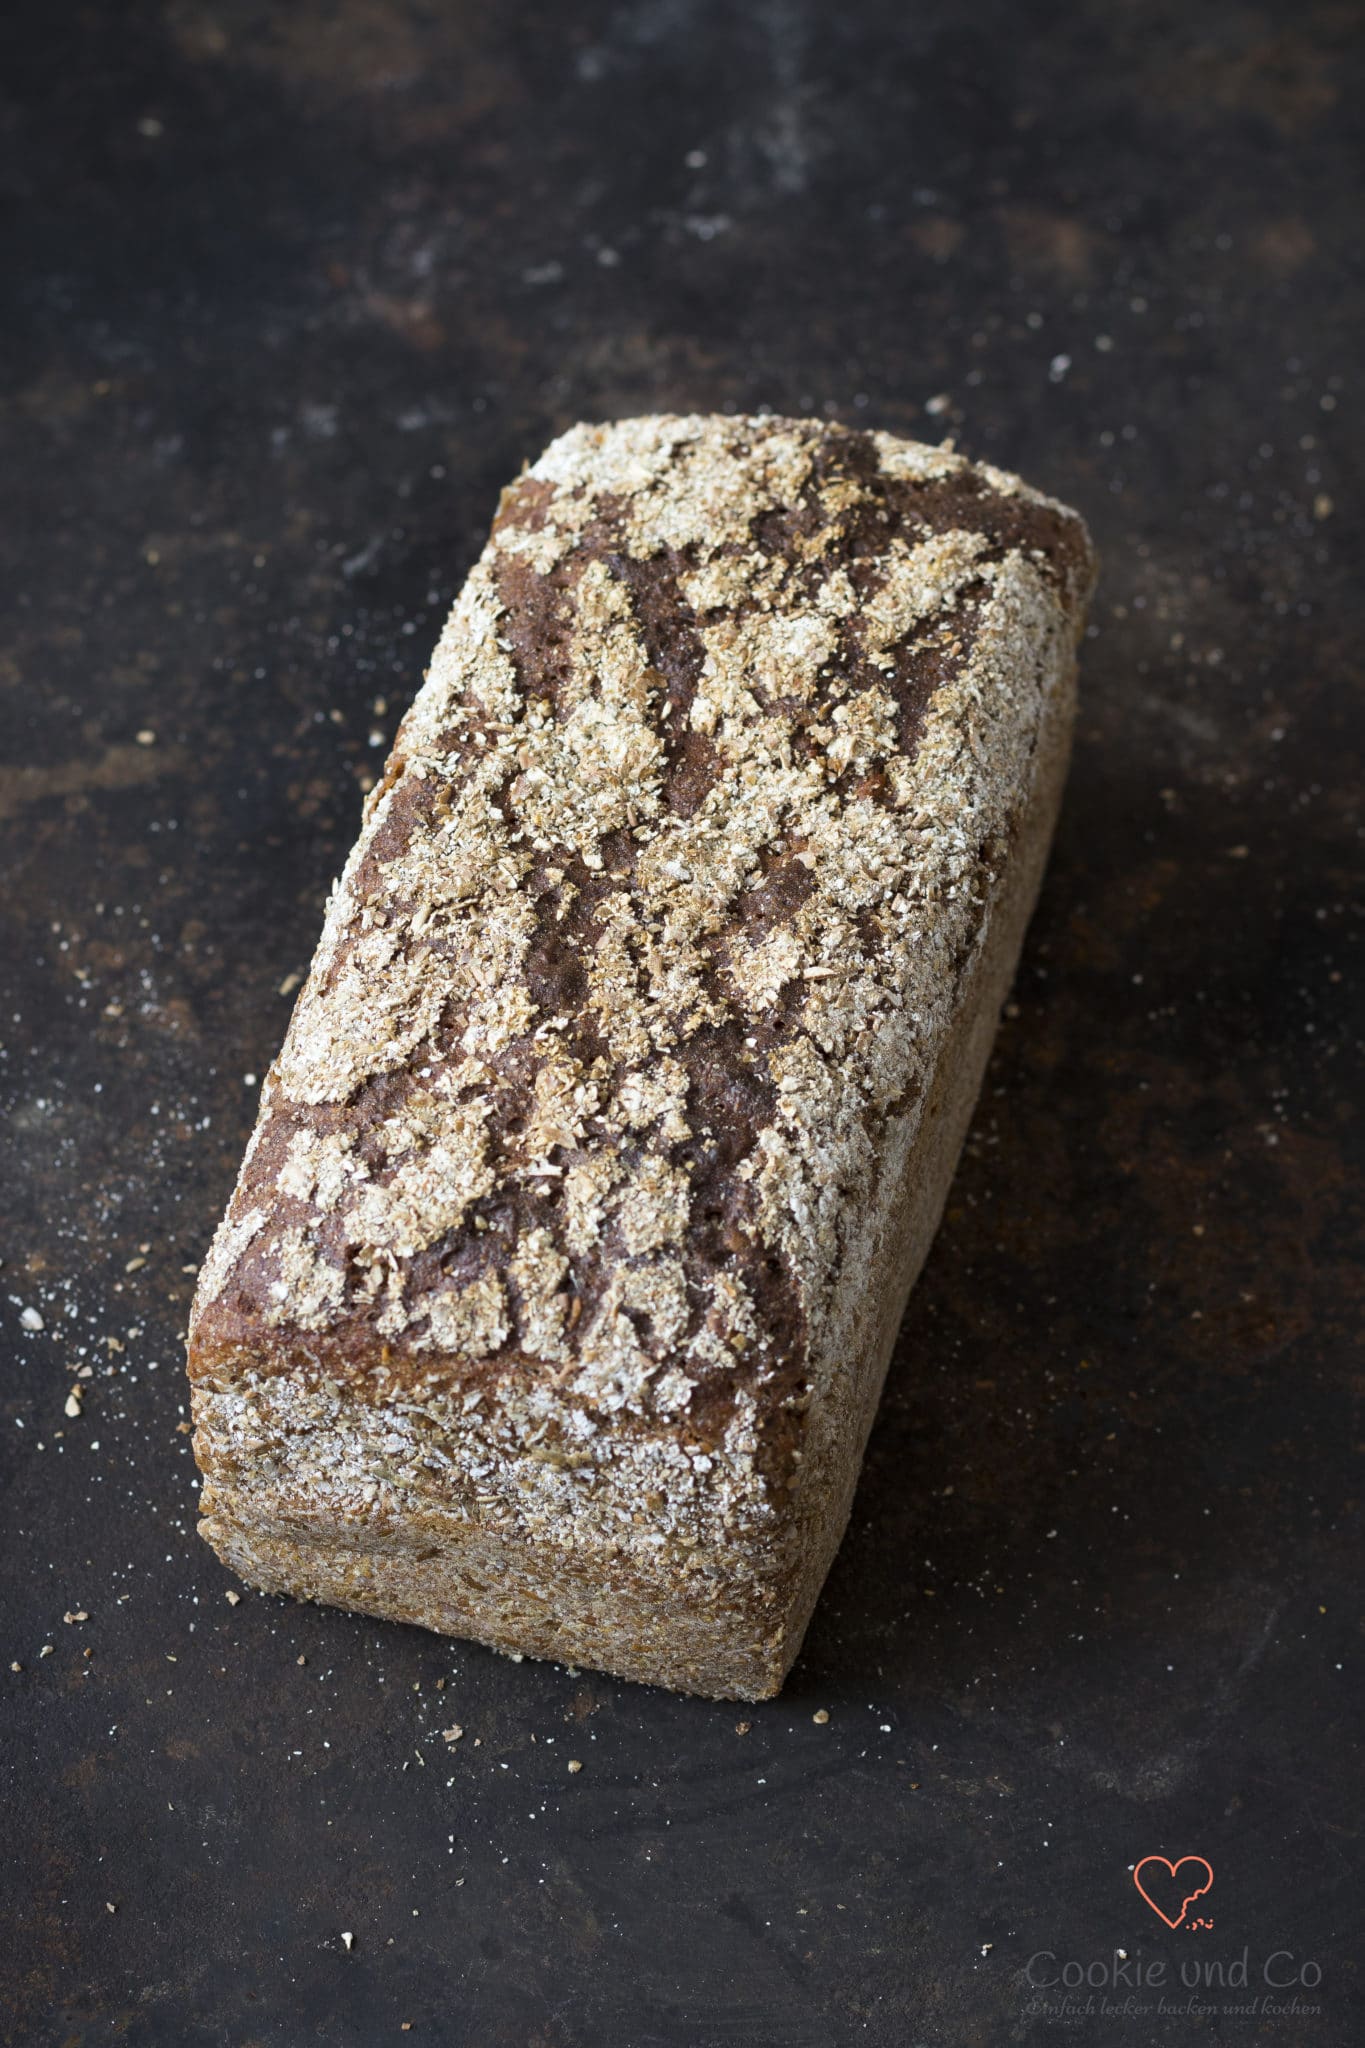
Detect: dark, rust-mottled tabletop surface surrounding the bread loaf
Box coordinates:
(0, 0, 1365, 2048)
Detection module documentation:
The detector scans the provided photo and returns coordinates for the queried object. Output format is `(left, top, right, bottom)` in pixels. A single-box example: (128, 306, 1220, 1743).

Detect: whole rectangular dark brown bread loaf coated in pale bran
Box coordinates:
(190, 418, 1095, 1698)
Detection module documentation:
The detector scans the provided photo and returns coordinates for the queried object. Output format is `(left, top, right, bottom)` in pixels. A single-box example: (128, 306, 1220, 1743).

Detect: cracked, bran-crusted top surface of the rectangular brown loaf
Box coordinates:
(190, 416, 1093, 1474)
